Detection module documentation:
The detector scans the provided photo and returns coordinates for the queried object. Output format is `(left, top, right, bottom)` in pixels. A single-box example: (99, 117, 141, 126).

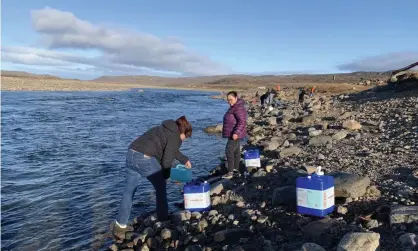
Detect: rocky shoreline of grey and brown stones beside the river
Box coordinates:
(109, 87, 418, 251)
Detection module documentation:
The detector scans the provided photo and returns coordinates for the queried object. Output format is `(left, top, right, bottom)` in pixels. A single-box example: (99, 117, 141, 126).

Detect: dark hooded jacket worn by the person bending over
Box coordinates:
(129, 120, 189, 179)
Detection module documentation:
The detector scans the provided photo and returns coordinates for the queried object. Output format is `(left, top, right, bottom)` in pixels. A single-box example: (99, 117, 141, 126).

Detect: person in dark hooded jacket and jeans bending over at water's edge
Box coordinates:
(113, 116, 192, 239)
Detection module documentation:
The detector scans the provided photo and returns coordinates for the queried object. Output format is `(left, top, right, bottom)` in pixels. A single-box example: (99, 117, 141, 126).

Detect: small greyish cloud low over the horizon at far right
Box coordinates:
(338, 51, 418, 71)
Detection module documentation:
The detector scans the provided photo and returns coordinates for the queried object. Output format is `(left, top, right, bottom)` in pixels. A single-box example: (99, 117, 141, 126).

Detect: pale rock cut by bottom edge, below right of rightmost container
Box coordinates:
(337, 233, 380, 251)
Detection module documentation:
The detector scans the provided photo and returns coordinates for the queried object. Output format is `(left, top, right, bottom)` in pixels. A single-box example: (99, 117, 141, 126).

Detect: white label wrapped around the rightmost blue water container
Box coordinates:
(296, 187, 335, 210)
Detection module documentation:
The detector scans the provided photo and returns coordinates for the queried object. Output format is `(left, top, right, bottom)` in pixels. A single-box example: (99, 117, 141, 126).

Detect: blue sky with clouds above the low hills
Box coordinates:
(1, 0, 418, 79)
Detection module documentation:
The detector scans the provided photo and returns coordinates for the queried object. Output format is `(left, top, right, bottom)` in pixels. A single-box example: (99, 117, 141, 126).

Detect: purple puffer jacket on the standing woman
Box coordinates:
(222, 99, 247, 139)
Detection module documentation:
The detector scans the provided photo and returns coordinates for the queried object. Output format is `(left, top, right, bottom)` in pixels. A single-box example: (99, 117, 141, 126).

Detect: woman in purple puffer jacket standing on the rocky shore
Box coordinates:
(222, 91, 247, 179)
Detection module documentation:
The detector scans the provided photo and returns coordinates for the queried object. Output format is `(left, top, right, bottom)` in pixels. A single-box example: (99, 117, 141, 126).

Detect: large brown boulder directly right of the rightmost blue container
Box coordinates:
(329, 172, 370, 198)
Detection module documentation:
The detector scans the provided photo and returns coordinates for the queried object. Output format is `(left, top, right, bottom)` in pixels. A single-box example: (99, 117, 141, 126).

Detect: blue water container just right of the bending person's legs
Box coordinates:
(183, 181, 211, 212)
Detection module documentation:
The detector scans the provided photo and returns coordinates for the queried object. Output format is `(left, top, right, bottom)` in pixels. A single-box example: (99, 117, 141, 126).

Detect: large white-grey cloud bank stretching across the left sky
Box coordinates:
(2, 8, 229, 75)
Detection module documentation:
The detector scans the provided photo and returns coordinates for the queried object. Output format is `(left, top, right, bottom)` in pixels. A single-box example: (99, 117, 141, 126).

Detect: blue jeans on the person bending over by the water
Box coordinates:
(116, 149, 168, 225)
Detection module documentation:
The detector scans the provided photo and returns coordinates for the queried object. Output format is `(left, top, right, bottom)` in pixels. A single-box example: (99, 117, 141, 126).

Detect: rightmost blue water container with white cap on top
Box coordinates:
(296, 167, 335, 217)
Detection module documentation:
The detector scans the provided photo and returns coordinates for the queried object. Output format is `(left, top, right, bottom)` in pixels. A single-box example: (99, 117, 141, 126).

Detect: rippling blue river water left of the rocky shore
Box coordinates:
(1, 90, 227, 250)
